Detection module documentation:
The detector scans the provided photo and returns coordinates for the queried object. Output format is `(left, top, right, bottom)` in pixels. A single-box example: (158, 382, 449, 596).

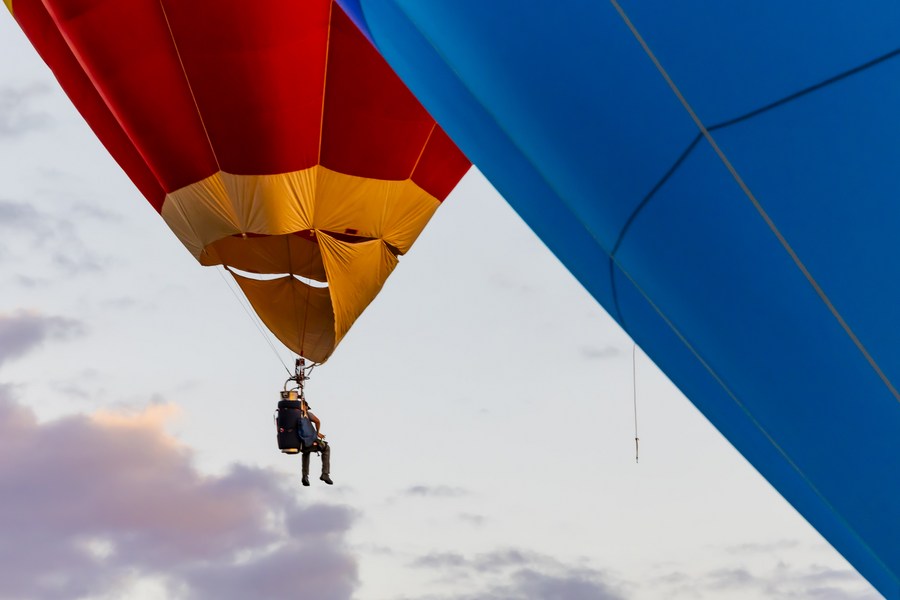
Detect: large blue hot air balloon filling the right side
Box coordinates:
(341, 0, 900, 598)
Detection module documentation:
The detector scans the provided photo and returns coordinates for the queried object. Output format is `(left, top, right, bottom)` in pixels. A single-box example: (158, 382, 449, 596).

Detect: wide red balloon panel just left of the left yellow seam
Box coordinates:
(44, 0, 218, 192)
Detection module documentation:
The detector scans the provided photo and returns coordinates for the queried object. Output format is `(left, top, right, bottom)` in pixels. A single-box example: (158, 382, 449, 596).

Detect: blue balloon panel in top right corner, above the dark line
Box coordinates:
(620, 0, 900, 126)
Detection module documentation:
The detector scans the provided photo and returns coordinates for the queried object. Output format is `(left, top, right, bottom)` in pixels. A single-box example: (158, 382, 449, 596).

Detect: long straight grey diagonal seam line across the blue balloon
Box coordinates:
(610, 0, 900, 402)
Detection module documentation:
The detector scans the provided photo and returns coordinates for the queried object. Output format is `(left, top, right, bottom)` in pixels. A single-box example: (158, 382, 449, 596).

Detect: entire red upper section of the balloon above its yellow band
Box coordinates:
(15, 0, 468, 202)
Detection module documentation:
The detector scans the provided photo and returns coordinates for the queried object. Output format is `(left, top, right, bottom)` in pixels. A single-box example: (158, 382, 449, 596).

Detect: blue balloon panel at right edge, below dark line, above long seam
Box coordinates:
(716, 58, 900, 390)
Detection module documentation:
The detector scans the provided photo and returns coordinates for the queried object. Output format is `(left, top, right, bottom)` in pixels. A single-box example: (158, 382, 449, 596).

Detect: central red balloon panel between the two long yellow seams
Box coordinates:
(163, 0, 331, 175)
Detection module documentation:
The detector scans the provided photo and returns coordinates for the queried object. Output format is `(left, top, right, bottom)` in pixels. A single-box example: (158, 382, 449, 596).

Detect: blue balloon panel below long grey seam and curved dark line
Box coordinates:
(618, 142, 900, 580)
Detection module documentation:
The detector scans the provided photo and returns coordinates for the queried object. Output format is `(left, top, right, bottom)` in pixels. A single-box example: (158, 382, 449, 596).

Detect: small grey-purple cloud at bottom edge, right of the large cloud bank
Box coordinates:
(413, 549, 625, 600)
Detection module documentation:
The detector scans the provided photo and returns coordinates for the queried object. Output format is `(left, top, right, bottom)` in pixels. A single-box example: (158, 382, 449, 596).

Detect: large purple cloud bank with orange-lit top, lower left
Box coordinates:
(0, 387, 358, 600)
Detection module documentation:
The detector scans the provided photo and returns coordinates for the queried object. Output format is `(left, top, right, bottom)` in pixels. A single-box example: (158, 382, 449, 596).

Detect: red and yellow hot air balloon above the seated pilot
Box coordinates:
(6, 0, 470, 363)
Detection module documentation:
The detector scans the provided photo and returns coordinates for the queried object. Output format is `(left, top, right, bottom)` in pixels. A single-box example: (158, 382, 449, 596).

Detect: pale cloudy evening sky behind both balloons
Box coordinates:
(0, 15, 880, 600)
